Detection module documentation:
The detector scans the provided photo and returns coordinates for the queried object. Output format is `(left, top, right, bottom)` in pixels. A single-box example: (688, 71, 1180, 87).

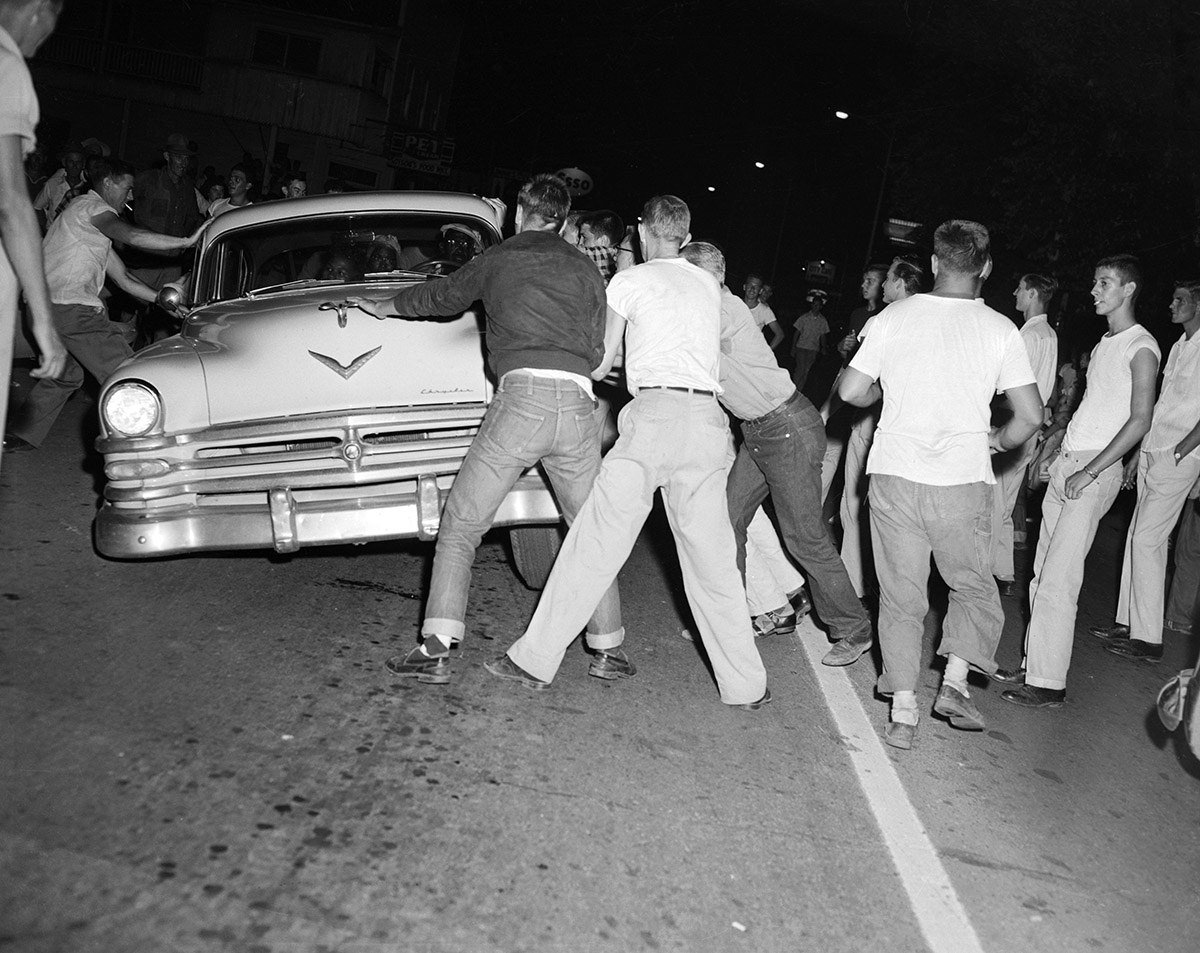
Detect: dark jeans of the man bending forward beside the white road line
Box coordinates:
(726, 392, 871, 639)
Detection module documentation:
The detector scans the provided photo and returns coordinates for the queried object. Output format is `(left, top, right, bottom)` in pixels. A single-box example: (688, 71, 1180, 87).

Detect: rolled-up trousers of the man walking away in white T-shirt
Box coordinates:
(868, 473, 1004, 695)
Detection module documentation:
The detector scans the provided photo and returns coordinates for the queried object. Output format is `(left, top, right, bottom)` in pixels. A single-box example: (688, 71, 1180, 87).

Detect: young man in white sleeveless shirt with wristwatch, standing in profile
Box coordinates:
(997, 254, 1161, 708)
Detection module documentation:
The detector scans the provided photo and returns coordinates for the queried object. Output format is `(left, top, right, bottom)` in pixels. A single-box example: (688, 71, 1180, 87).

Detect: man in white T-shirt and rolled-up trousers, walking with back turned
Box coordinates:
(838, 220, 1042, 748)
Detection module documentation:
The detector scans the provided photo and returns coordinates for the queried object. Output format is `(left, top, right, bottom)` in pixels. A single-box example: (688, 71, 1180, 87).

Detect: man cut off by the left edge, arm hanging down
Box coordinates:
(0, 0, 67, 465)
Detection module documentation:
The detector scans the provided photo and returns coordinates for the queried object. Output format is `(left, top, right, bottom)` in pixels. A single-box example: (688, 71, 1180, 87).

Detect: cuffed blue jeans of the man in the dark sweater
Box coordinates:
(421, 371, 624, 648)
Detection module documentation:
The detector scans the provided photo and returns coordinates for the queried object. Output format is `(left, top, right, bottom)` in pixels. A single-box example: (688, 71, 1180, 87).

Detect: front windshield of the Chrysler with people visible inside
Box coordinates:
(197, 211, 497, 302)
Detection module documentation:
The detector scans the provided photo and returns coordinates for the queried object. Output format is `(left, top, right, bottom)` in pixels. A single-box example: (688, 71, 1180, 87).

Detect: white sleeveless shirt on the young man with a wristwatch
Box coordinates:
(1062, 324, 1163, 451)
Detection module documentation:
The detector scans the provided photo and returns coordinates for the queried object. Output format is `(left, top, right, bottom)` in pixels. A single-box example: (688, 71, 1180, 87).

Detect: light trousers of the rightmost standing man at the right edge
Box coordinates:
(1117, 450, 1200, 645)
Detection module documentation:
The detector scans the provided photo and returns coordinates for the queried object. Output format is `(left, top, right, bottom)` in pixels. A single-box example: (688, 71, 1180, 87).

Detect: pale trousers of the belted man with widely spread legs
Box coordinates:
(508, 390, 767, 705)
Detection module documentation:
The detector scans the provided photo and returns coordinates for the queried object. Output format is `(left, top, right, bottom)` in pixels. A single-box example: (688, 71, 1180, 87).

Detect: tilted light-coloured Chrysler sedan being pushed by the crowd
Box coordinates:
(95, 192, 560, 587)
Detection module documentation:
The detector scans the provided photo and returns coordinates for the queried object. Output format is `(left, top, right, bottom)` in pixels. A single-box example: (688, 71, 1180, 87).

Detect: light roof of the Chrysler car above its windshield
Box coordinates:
(203, 191, 504, 245)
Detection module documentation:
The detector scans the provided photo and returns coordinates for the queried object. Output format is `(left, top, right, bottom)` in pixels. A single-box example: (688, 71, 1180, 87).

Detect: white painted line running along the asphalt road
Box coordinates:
(796, 619, 983, 953)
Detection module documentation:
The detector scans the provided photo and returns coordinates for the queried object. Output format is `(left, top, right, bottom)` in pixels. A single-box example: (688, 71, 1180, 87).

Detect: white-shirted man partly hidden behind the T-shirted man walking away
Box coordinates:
(991, 275, 1058, 595)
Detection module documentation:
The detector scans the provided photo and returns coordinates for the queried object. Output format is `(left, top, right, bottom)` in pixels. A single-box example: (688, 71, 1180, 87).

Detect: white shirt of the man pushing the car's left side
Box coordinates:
(42, 192, 113, 307)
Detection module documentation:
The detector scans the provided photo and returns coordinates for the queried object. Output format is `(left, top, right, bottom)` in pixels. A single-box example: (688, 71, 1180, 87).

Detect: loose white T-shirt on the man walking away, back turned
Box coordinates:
(850, 294, 1034, 486)
